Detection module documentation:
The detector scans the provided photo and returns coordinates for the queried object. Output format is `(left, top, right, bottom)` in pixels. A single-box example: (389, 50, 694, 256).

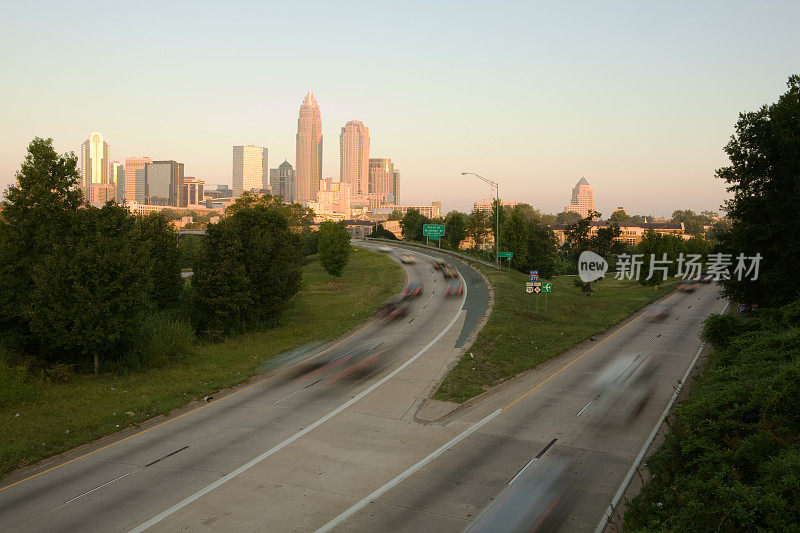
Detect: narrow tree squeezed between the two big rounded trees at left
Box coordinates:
(136, 213, 183, 309)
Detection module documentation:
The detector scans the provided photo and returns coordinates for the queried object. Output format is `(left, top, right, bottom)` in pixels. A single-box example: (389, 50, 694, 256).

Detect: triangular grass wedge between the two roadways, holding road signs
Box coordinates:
(432, 268, 673, 403)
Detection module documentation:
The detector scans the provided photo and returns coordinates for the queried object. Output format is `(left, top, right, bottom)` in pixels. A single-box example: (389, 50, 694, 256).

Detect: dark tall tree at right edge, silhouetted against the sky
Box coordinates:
(716, 75, 800, 306)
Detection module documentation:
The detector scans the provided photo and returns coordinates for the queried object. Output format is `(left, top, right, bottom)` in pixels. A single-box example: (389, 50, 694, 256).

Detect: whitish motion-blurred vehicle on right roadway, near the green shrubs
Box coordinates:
(593, 354, 658, 424)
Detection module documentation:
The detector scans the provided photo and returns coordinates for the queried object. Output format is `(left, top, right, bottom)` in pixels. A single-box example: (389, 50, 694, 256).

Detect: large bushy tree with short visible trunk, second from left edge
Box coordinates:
(29, 202, 151, 374)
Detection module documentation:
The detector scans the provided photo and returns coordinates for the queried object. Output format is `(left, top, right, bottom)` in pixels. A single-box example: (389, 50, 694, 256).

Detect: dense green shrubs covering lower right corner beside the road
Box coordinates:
(624, 301, 800, 531)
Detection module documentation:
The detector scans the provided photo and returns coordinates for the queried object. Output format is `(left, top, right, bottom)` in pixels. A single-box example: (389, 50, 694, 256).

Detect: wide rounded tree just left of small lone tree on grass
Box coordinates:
(192, 203, 302, 337)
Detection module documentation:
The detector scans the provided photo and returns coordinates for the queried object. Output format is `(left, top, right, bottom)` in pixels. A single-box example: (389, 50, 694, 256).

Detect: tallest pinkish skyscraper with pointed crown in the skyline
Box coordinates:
(295, 91, 322, 204)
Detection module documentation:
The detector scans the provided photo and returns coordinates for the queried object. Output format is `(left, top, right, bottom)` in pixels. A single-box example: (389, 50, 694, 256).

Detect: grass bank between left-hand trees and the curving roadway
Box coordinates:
(0, 249, 404, 475)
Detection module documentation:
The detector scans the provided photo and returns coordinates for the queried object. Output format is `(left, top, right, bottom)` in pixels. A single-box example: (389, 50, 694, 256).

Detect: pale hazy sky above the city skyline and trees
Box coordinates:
(0, 0, 800, 215)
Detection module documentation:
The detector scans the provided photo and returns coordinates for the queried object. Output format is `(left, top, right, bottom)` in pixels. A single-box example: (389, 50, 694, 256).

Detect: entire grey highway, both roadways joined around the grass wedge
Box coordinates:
(0, 244, 724, 533)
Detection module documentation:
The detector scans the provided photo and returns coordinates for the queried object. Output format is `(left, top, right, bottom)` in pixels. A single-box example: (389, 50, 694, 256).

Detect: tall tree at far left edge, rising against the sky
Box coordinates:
(0, 137, 83, 351)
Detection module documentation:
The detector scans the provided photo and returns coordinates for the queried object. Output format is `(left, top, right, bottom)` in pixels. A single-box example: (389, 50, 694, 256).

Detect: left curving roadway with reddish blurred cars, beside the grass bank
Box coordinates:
(0, 244, 488, 531)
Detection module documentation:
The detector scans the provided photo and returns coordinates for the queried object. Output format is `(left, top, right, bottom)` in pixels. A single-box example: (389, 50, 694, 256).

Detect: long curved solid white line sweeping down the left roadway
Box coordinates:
(129, 289, 467, 533)
